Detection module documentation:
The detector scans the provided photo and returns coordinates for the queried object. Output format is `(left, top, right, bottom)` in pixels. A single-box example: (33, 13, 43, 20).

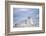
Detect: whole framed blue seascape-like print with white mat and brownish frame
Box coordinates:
(5, 1, 45, 35)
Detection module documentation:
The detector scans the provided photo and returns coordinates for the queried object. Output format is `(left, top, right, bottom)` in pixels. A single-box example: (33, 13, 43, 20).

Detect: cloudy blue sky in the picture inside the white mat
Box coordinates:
(13, 8, 39, 24)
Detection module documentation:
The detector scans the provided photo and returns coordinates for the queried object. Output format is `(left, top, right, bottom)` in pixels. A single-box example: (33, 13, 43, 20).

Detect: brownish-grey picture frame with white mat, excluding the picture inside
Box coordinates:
(5, 1, 45, 35)
